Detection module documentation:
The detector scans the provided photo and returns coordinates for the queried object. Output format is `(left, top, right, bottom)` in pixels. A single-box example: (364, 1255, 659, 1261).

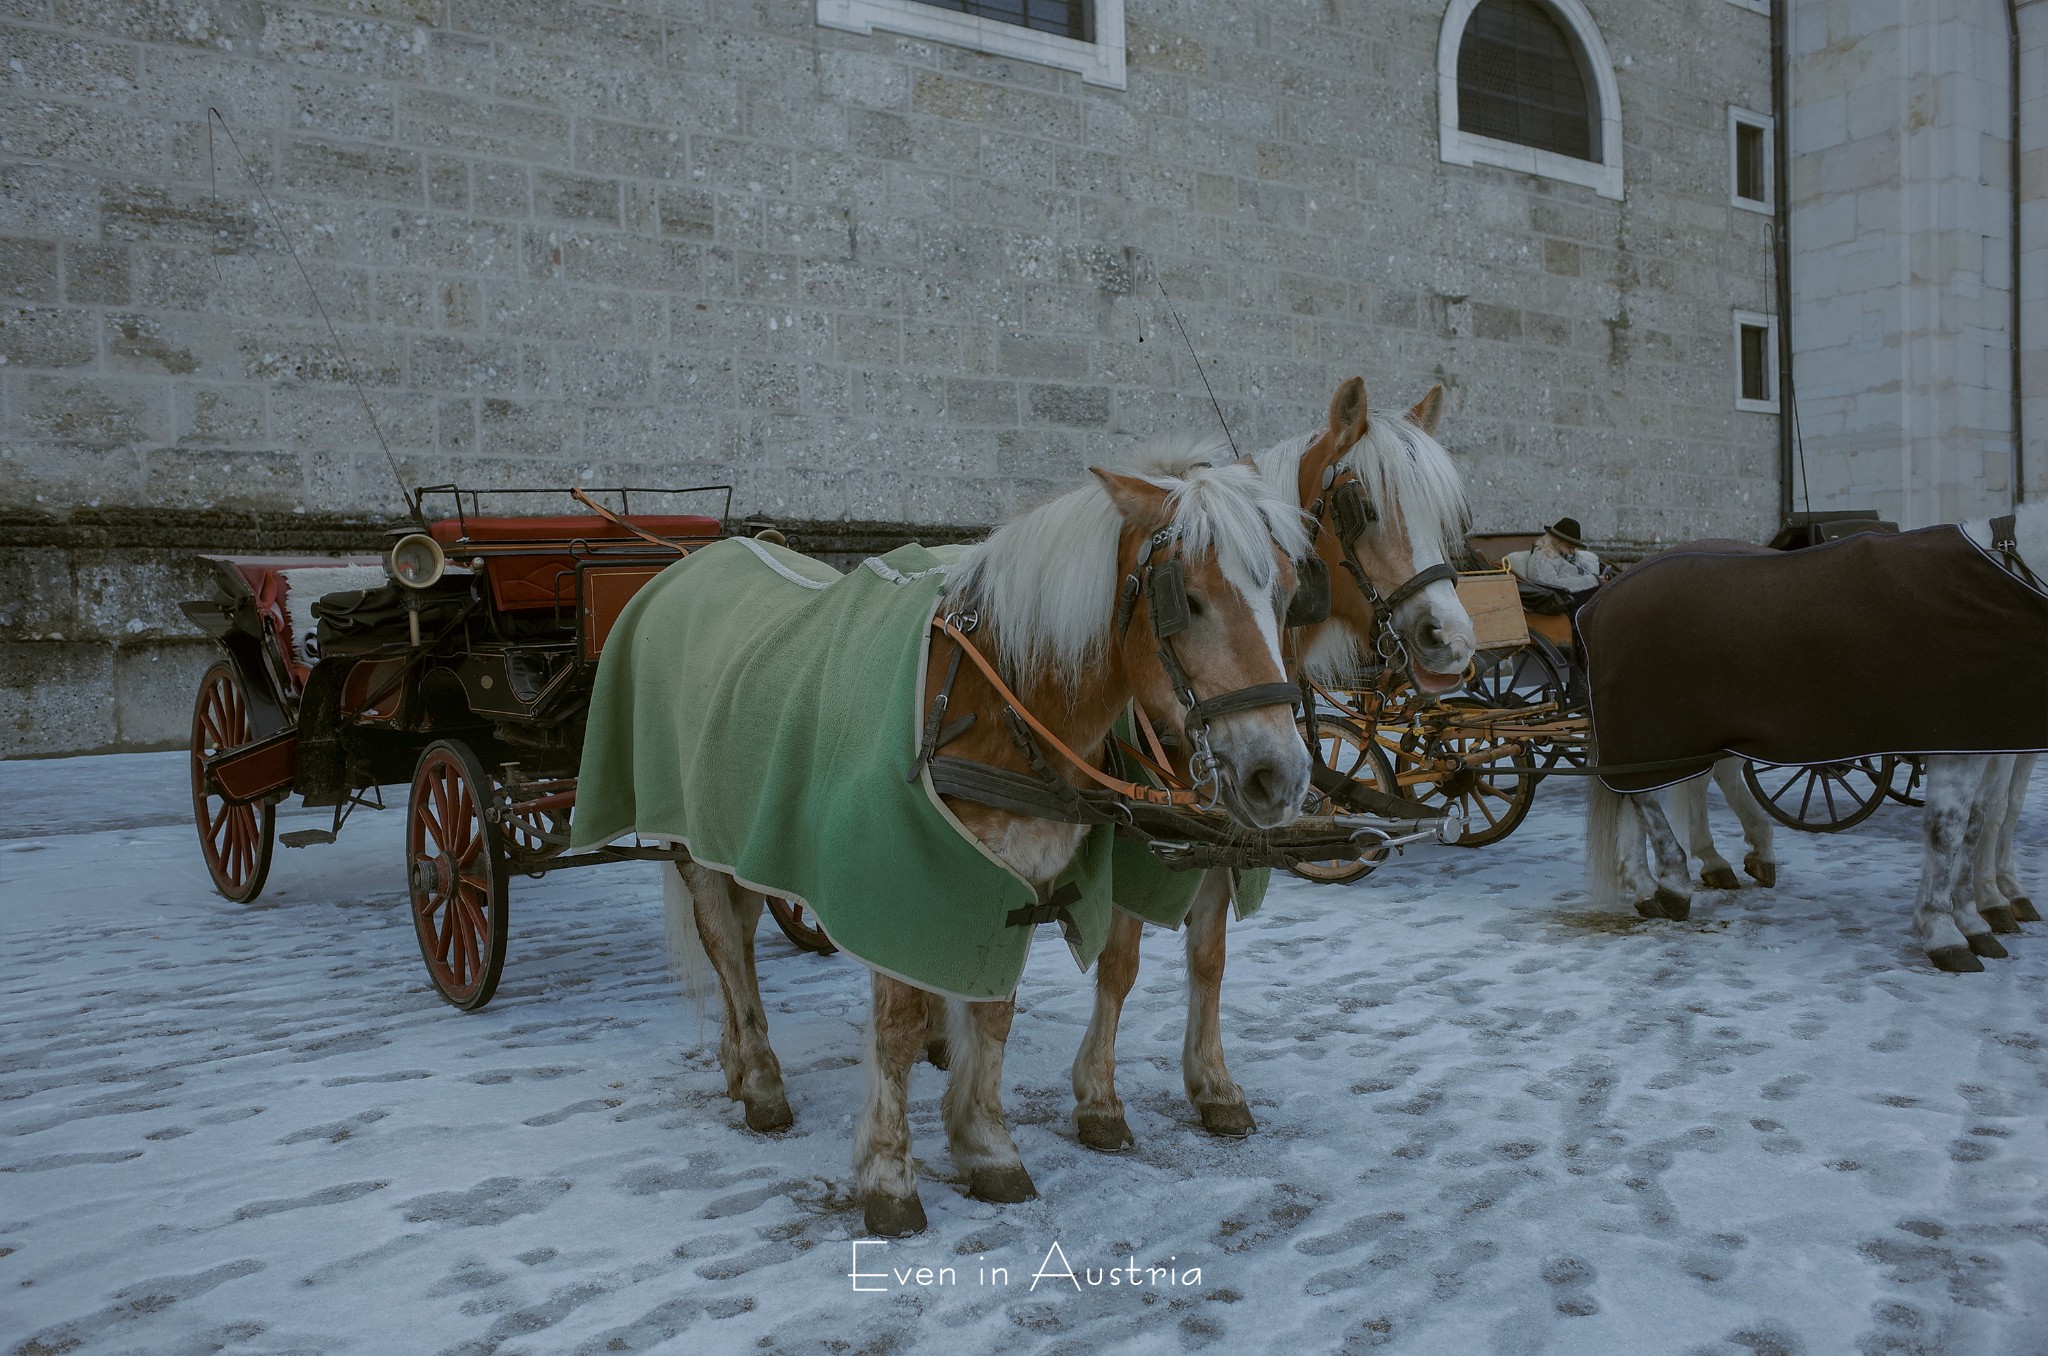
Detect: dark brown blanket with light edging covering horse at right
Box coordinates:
(1579, 526, 2048, 793)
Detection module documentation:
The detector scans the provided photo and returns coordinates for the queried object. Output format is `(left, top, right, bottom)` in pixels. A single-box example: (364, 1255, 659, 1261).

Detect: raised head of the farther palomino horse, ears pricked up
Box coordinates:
(1296, 377, 1475, 692)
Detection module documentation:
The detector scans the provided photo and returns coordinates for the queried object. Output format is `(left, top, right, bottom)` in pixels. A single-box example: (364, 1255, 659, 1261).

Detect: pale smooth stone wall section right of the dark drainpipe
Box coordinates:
(1790, 0, 2048, 526)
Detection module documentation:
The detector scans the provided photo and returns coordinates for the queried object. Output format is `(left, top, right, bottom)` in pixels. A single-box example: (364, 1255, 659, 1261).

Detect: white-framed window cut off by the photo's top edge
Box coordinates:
(817, 0, 1124, 90)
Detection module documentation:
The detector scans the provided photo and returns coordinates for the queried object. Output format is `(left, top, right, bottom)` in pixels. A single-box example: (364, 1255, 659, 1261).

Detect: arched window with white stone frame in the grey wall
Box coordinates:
(1436, 0, 1622, 199)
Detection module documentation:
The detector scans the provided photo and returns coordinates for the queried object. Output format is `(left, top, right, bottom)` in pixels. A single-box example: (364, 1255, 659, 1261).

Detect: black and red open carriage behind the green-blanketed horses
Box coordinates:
(182, 485, 731, 1010)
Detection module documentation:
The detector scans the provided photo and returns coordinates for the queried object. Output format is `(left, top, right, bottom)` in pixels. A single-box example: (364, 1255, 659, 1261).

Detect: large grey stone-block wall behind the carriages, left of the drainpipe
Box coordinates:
(0, 0, 1776, 752)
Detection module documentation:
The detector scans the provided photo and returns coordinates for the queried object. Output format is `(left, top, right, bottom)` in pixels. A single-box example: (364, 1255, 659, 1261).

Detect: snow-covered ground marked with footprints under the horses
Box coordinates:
(0, 754, 2048, 1356)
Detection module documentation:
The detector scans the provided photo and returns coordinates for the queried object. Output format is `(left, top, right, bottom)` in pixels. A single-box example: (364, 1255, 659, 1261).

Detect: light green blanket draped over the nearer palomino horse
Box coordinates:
(571, 539, 1264, 1000)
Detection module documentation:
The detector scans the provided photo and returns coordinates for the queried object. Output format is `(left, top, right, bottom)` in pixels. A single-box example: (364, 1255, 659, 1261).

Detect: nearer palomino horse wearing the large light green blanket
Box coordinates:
(670, 442, 1309, 1237)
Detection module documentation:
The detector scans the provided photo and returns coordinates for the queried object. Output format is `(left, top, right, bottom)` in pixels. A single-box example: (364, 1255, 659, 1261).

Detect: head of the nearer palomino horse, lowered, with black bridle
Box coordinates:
(1096, 463, 1309, 830)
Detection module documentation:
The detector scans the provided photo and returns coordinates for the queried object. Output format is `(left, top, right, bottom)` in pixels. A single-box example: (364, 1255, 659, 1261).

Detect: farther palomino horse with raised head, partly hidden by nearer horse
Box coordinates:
(1073, 377, 1475, 1151)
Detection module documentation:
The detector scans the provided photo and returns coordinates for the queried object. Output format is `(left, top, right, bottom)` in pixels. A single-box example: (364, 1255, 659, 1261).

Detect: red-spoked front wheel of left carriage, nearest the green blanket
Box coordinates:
(406, 739, 508, 1012)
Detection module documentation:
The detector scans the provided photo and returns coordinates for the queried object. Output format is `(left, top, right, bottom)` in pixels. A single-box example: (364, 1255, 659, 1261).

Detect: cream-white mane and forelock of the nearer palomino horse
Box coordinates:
(944, 436, 1309, 682)
